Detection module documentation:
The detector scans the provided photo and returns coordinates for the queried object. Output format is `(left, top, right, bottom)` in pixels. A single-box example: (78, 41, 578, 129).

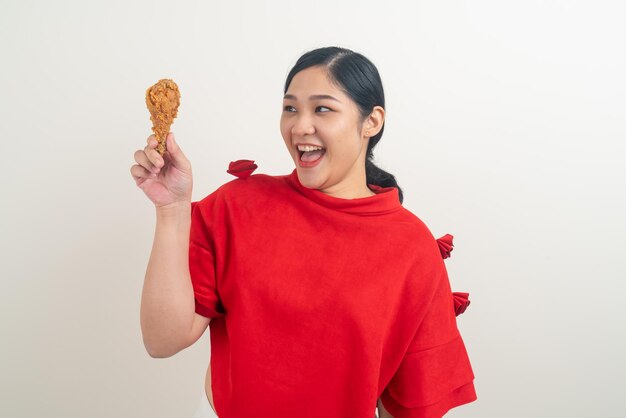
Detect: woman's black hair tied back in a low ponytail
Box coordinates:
(284, 46, 403, 203)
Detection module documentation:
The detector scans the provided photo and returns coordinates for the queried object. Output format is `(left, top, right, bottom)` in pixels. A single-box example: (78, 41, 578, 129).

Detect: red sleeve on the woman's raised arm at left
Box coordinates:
(189, 191, 224, 318)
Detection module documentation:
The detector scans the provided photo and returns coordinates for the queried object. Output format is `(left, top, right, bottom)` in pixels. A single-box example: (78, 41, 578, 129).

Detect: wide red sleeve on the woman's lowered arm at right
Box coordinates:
(381, 261, 477, 418)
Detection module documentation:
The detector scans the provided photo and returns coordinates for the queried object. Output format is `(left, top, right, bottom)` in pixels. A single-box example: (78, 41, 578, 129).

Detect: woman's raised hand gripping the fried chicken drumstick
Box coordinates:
(130, 132, 193, 209)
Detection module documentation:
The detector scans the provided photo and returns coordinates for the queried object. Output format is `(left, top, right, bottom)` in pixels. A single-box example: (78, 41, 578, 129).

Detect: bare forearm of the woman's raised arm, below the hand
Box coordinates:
(141, 202, 194, 357)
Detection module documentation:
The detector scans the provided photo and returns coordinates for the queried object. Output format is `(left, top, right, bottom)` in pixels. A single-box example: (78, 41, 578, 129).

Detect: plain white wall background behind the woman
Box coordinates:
(0, 0, 626, 418)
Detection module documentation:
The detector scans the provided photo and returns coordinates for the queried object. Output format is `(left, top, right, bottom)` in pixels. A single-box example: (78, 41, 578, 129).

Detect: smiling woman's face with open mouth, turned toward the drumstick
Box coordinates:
(280, 66, 373, 199)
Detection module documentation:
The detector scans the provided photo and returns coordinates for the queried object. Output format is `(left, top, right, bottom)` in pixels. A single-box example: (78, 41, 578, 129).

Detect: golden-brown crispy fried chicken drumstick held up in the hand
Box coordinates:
(146, 79, 180, 155)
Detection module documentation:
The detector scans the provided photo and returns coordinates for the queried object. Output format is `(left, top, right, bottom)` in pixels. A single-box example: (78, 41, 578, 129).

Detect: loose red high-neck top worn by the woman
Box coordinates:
(189, 165, 477, 418)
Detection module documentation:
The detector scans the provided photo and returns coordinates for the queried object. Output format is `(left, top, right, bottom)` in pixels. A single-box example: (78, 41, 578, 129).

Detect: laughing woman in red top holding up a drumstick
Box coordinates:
(131, 47, 476, 418)
